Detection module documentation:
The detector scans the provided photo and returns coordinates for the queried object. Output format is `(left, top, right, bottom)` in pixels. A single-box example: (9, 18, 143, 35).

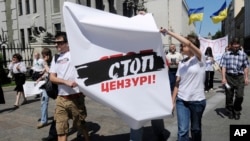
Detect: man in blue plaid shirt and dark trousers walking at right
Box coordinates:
(220, 38, 249, 120)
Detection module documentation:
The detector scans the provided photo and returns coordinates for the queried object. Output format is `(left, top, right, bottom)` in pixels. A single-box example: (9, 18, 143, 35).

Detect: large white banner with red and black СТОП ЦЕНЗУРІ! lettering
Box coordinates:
(63, 2, 173, 129)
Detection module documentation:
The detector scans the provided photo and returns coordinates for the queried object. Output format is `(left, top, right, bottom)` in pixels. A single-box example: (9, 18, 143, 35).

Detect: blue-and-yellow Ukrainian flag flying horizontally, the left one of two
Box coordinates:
(188, 7, 204, 25)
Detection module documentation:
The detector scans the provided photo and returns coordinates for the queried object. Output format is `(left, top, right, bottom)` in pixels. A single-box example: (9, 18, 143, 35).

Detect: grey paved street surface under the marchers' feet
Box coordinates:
(0, 73, 250, 141)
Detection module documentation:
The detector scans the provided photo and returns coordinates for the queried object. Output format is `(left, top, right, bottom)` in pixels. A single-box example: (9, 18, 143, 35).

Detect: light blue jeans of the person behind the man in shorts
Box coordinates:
(41, 89, 49, 124)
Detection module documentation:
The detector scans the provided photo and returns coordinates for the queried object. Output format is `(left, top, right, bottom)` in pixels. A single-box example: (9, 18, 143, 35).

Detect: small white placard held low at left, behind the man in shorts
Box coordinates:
(23, 81, 45, 97)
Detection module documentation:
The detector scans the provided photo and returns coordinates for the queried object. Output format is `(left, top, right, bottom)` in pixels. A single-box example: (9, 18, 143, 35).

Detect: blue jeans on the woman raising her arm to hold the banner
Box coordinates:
(176, 97, 206, 141)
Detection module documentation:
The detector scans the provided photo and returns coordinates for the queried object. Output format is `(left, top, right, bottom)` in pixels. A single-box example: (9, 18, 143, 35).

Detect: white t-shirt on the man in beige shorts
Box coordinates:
(49, 52, 79, 96)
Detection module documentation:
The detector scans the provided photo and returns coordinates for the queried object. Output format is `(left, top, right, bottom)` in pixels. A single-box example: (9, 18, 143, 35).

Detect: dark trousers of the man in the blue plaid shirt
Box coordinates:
(225, 75, 245, 114)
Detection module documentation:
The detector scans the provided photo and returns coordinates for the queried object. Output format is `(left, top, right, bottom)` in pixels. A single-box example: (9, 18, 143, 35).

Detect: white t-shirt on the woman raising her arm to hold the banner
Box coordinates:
(176, 55, 206, 101)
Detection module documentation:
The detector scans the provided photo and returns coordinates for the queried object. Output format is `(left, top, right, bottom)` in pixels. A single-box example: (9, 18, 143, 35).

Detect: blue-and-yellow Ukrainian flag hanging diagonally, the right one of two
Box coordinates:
(210, 1, 227, 24)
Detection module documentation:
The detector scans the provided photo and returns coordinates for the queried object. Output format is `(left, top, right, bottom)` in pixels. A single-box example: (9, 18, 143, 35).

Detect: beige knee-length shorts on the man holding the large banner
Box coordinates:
(54, 94, 87, 135)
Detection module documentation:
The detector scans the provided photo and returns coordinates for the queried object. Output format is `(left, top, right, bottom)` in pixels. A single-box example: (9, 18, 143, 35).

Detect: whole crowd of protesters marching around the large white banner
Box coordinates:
(0, 17, 249, 141)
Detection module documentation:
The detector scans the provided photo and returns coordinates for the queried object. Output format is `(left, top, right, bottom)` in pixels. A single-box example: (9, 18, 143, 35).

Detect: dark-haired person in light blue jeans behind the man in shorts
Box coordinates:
(36, 48, 52, 128)
